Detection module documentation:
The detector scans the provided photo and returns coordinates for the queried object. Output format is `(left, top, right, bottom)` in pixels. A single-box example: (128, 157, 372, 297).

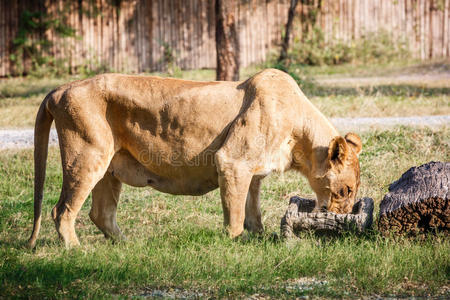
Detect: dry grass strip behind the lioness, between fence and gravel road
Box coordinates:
(0, 62, 450, 128)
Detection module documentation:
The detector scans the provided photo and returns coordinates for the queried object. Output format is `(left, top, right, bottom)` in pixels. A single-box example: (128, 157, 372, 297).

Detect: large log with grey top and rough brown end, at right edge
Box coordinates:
(378, 162, 450, 234)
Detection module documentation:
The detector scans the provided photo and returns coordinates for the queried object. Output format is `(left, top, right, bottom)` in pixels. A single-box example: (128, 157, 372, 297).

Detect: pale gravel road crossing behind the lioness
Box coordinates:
(0, 115, 450, 150)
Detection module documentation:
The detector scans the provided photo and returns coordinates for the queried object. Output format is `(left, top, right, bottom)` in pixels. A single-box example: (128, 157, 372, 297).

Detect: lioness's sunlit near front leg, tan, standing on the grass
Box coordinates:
(217, 158, 252, 238)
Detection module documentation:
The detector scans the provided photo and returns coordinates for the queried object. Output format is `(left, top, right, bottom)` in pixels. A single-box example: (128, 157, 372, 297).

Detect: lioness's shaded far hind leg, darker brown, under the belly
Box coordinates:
(89, 172, 125, 240)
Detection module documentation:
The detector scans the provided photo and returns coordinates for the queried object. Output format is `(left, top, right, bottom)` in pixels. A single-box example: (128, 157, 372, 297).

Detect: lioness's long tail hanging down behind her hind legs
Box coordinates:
(28, 92, 54, 248)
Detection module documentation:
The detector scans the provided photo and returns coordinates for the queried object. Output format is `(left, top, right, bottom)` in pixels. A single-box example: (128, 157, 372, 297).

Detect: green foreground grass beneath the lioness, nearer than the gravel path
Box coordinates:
(0, 127, 450, 298)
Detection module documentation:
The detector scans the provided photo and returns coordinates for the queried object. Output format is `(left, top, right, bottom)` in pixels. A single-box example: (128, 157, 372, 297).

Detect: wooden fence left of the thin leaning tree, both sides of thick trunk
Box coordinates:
(0, 0, 289, 76)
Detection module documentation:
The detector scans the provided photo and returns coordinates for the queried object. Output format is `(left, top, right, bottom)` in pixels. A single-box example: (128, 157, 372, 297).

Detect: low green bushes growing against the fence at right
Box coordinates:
(289, 27, 410, 66)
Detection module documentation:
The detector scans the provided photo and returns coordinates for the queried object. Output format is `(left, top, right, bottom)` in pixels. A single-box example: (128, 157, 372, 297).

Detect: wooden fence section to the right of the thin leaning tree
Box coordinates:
(297, 0, 450, 60)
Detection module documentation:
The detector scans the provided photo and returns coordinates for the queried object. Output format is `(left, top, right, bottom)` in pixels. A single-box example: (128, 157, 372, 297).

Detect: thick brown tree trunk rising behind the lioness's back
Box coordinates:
(216, 0, 239, 81)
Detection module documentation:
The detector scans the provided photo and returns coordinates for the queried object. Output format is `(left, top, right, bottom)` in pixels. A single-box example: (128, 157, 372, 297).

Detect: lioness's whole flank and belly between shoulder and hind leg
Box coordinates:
(101, 75, 245, 195)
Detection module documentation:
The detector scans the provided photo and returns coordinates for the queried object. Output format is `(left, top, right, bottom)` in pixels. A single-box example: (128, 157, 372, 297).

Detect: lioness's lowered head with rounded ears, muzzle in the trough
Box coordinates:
(309, 133, 362, 213)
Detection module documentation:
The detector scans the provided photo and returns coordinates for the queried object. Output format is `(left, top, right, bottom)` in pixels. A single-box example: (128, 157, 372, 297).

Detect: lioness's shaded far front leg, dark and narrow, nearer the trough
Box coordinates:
(244, 176, 264, 233)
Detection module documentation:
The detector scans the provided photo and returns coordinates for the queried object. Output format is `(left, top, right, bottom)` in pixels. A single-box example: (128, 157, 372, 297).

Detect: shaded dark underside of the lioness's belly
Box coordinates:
(108, 150, 218, 195)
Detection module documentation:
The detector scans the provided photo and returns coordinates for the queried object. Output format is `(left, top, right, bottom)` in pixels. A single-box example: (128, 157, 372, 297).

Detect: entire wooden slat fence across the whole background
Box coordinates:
(0, 0, 450, 76)
